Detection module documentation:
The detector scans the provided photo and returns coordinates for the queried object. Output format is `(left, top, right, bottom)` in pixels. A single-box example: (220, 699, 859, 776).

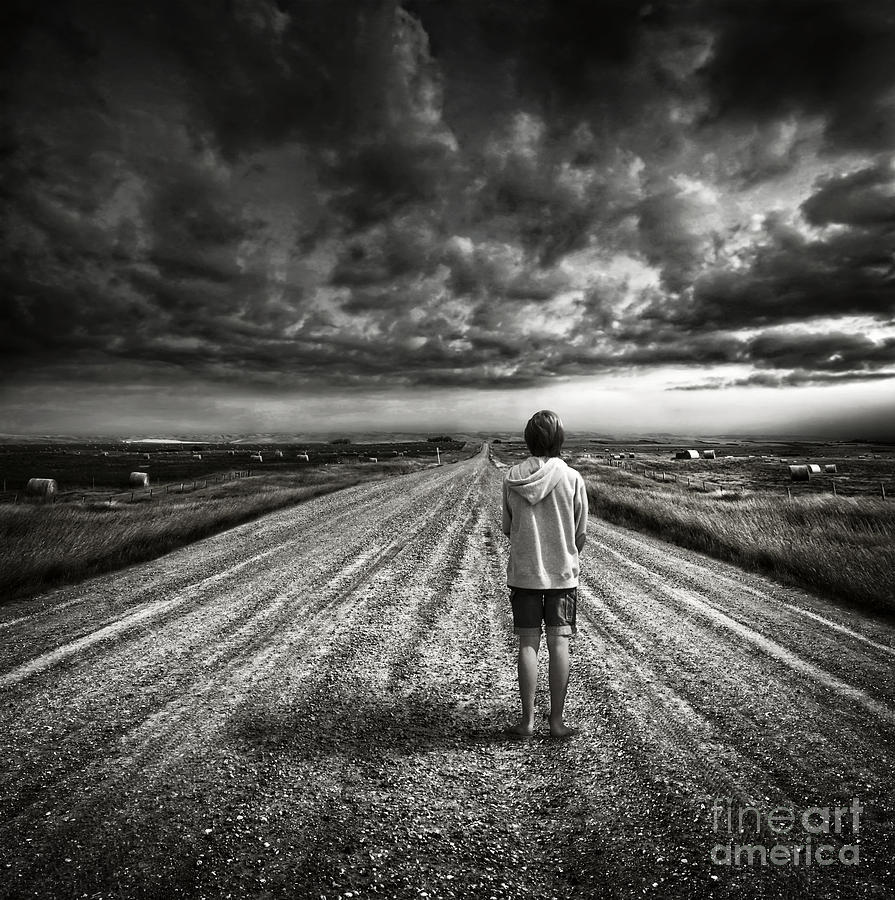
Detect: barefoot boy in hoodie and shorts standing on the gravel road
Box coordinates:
(503, 409, 587, 738)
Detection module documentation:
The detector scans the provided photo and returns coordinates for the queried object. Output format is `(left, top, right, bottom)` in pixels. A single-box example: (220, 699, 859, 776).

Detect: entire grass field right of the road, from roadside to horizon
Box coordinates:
(494, 442, 895, 614)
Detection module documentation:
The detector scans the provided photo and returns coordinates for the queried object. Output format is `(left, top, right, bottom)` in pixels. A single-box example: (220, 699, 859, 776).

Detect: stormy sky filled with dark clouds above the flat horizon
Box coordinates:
(0, 0, 895, 438)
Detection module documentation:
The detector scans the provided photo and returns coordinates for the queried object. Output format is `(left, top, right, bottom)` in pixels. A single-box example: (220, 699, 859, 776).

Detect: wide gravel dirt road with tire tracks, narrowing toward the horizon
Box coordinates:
(0, 447, 895, 900)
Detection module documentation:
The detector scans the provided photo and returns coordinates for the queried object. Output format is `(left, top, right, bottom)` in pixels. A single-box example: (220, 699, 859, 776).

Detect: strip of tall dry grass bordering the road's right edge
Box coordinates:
(582, 467, 895, 613)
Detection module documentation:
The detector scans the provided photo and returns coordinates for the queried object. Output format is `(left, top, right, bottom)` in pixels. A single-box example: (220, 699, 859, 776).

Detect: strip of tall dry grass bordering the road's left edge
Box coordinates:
(0, 463, 418, 602)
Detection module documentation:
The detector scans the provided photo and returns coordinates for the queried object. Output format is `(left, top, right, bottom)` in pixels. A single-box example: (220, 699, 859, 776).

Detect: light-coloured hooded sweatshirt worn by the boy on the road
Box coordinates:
(503, 456, 587, 590)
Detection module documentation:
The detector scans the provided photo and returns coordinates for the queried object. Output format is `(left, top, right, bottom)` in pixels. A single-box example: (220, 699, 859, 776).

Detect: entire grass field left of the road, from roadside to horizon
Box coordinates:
(0, 444, 474, 602)
